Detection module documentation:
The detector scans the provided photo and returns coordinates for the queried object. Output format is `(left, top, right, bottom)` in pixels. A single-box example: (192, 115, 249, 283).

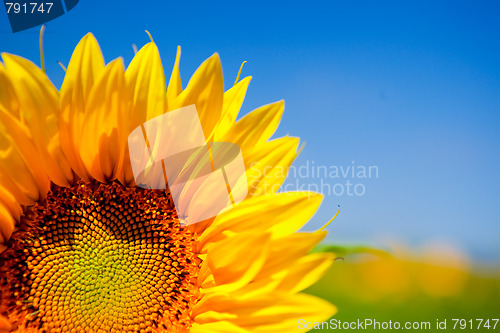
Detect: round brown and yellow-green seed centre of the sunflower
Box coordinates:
(0, 182, 200, 332)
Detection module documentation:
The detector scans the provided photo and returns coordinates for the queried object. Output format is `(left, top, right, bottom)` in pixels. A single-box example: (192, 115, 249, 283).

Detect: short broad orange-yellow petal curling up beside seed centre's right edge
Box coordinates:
(199, 233, 270, 292)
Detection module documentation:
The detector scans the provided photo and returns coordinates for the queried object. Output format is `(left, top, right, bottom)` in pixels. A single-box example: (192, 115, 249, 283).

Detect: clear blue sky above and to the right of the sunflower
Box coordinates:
(0, 0, 500, 260)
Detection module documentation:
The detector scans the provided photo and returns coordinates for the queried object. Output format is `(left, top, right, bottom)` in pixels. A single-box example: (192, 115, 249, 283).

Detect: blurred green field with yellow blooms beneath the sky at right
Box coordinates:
(304, 245, 500, 332)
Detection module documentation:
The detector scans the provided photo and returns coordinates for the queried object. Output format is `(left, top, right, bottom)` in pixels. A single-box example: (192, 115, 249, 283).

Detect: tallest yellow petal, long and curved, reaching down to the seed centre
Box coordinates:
(59, 33, 104, 179)
